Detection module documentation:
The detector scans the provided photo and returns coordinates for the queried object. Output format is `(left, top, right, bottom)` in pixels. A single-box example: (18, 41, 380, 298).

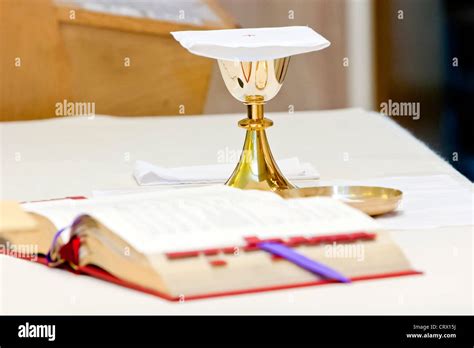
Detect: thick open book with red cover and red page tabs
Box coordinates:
(0, 186, 417, 300)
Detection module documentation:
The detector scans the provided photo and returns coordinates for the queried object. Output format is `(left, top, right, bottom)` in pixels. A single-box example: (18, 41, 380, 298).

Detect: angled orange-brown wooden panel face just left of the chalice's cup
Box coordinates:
(61, 24, 212, 116)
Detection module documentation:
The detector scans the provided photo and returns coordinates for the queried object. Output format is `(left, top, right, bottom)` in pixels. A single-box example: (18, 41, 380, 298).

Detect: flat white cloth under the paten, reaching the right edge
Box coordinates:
(320, 175, 474, 230)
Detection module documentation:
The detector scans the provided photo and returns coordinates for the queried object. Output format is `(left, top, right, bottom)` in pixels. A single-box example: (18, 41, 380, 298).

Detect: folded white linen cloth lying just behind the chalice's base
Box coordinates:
(133, 157, 319, 185)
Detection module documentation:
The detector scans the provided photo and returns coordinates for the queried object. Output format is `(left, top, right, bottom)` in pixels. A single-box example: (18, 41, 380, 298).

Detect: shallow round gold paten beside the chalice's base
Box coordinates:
(278, 186, 403, 216)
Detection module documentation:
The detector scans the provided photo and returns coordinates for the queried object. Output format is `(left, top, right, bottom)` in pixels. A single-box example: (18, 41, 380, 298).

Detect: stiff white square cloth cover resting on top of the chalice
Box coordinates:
(171, 26, 331, 62)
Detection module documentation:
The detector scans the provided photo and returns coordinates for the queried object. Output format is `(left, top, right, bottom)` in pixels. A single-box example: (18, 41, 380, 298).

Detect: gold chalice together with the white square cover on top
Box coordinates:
(171, 26, 330, 191)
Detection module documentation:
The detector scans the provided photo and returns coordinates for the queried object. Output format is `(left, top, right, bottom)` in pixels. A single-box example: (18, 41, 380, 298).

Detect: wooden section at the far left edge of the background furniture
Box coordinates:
(0, 0, 71, 121)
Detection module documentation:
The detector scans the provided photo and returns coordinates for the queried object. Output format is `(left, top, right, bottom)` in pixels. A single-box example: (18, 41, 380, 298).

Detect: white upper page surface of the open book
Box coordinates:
(23, 185, 379, 254)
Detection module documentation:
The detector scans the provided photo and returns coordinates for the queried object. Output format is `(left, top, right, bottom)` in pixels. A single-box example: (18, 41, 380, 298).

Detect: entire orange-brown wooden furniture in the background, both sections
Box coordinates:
(0, 0, 235, 121)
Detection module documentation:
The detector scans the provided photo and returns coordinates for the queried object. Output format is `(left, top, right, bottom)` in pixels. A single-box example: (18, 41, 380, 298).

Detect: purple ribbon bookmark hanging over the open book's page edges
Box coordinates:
(257, 242, 351, 283)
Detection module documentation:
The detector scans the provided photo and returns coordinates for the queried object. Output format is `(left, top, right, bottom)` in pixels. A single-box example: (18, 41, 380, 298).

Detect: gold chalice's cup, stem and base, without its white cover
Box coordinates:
(218, 57, 295, 191)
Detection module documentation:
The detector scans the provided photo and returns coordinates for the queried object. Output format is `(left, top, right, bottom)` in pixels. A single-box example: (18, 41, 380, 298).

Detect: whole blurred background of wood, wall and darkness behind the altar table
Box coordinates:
(0, 0, 474, 180)
